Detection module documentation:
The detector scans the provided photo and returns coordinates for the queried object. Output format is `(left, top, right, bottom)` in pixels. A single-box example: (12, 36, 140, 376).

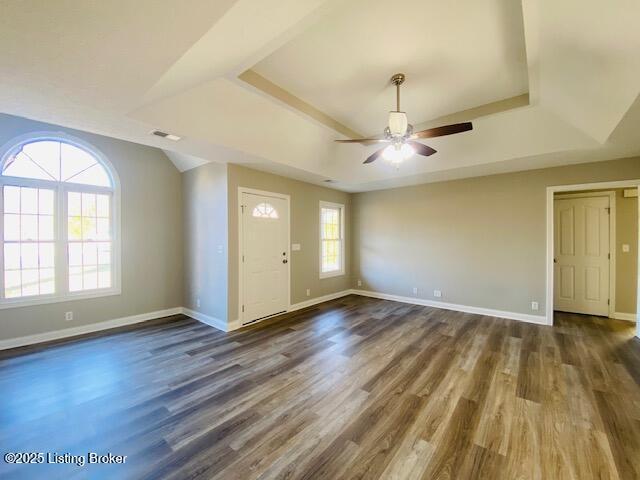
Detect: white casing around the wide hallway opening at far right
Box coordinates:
(545, 179, 640, 328)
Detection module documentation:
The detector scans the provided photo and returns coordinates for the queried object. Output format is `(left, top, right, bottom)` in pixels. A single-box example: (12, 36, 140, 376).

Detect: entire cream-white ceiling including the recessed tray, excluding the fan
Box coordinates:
(0, 0, 640, 191)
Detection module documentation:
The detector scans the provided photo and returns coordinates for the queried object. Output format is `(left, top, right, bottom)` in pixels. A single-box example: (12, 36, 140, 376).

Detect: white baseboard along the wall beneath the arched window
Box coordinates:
(0, 307, 182, 350)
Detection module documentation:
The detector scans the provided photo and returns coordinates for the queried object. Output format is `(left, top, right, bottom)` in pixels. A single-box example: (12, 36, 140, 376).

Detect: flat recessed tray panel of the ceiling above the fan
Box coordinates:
(253, 0, 528, 134)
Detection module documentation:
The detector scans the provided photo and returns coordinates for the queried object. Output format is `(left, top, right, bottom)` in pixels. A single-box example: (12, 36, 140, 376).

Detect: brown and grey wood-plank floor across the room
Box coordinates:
(0, 296, 640, 480)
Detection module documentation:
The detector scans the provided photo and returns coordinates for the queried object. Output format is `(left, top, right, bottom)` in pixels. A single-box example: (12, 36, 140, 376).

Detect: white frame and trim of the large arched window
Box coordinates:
(0, 132, 122, 310)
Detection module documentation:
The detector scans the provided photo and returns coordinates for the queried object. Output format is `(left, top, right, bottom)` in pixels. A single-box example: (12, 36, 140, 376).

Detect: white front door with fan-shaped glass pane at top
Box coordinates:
(240, 192, 289, 324)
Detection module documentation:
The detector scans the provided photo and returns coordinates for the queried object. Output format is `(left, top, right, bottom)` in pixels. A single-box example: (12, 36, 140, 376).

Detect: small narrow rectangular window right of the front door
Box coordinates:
(320, 202, 344, 278)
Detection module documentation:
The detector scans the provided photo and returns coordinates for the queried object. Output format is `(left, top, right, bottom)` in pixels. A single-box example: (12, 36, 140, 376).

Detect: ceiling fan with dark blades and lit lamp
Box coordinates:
(336, 73, 473, 165)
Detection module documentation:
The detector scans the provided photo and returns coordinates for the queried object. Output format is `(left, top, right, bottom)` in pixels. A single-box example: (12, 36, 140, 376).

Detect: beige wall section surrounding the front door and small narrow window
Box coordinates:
(228, 165, 351, 322)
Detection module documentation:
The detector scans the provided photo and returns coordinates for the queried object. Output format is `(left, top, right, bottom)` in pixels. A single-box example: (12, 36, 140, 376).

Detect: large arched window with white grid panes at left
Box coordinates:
(0, 134, 120, 307)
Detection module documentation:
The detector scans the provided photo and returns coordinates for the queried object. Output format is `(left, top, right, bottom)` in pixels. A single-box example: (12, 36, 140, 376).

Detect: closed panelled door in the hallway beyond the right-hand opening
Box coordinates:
(554, 197, 610, 316)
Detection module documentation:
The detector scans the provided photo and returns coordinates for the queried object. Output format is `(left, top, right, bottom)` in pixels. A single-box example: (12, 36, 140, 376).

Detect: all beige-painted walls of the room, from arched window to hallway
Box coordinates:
(0, 115, 640, 339)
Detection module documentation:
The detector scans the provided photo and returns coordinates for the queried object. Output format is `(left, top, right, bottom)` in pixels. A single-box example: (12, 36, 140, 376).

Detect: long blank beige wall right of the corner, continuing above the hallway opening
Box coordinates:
(352, 158, 640, 315)
